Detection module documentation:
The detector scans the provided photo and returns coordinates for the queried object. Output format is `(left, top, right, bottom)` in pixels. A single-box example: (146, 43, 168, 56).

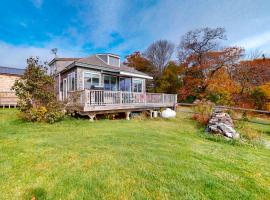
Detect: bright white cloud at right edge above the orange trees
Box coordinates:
(235, 31, 270, 50)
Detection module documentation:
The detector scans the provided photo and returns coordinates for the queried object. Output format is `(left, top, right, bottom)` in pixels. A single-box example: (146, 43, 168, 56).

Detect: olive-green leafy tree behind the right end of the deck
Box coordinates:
(158, 62, 182, 94)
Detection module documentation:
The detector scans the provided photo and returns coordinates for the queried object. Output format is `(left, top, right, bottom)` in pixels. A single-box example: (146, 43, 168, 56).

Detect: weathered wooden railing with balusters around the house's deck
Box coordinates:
(68, 89, 177, 107)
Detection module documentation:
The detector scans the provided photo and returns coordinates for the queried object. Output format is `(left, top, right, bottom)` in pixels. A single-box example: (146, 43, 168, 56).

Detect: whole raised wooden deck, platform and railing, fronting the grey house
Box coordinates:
(67, 89, 177, 114)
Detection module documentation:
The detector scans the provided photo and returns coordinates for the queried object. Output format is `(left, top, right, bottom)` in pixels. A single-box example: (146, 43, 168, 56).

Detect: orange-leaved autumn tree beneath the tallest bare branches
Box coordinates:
(179, 47, 244, 103)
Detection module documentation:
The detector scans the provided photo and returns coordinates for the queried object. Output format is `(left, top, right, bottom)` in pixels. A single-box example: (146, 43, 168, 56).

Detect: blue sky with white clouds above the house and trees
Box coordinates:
(0, 0, 270, 67)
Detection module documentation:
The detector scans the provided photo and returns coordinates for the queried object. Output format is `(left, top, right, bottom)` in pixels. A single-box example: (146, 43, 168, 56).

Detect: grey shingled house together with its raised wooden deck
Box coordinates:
(49, 53, 177, 119)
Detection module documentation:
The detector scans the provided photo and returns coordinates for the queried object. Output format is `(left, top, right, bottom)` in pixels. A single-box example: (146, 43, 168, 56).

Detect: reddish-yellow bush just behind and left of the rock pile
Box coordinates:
(192, 100, 214, 125)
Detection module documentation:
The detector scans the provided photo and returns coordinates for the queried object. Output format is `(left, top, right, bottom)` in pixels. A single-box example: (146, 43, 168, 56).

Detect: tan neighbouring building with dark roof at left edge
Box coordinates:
(0, 66, 24, 107)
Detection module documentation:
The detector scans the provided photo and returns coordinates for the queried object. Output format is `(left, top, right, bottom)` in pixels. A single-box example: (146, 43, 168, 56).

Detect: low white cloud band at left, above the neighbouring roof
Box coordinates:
(0, 41, 82, 68)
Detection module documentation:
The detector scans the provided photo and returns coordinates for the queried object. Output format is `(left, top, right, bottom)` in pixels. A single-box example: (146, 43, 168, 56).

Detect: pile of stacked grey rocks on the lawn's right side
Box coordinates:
(206, 110, 239, 139)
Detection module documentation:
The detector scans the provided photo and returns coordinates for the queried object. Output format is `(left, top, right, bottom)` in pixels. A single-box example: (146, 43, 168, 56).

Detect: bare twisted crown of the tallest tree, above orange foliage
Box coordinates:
(178, 27, 226, 65)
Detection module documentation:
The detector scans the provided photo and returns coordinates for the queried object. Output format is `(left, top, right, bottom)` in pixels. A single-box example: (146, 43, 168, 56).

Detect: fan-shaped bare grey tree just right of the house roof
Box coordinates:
(144, 40, 174, 73)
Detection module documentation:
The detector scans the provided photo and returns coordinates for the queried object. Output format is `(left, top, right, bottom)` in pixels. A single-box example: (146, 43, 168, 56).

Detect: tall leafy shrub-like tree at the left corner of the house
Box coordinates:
(12, 57, 64, 123)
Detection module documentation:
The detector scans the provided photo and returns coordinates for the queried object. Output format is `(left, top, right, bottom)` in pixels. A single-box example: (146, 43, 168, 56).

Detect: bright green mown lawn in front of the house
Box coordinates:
(0, 109, 270, 200)
